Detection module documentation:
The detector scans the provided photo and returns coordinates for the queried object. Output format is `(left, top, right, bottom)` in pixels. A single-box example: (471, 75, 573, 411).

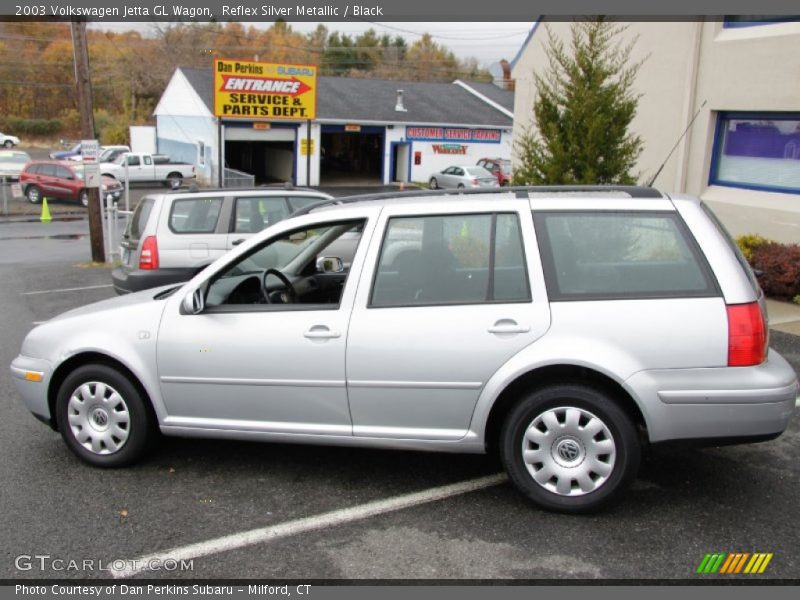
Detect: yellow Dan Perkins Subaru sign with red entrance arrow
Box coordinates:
(214, 59, 317, 120)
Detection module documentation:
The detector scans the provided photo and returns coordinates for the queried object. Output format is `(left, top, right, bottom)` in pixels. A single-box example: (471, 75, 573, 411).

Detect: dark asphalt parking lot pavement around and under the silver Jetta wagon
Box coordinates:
(0, 261, 800, 580)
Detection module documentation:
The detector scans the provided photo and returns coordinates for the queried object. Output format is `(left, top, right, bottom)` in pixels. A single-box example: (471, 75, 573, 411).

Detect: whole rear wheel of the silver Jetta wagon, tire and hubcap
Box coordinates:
(500, 384, 641, 513)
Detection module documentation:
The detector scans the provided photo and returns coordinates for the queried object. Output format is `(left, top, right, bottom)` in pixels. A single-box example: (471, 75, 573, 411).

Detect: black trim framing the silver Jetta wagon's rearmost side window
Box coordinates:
(532, 209, 722, 302)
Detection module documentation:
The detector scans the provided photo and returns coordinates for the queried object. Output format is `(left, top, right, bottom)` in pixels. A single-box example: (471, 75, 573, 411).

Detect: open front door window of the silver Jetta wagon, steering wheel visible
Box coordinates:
(206, 220, 365, 311)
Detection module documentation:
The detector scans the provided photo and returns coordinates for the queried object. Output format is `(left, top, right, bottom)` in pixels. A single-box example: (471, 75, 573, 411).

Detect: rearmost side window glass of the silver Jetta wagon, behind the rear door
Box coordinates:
(534, 212, 718, 300)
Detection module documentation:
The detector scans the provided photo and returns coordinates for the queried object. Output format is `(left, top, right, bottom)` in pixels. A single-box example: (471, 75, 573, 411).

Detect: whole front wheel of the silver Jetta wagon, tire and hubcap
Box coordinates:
(56, 365, 157, 467)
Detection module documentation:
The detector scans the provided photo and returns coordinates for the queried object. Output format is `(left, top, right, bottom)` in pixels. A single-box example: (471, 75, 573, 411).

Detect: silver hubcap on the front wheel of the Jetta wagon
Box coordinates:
(67, 381, 131, 454)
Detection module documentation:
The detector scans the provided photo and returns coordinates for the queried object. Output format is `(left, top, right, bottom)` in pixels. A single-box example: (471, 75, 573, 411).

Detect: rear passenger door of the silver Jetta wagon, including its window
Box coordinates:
(347, 200, 550, 440)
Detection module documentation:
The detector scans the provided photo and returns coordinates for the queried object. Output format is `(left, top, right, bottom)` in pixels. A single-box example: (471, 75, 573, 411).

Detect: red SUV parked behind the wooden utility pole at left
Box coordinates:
(19, 160, 122, 206)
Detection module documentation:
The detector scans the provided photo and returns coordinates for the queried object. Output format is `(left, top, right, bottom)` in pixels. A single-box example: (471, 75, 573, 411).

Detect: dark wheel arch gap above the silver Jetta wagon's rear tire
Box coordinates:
(483, 364, 647, 452)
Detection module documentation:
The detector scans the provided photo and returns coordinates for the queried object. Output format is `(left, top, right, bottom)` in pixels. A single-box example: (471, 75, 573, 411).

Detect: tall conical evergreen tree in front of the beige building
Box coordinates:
(514, 19, 643, 185)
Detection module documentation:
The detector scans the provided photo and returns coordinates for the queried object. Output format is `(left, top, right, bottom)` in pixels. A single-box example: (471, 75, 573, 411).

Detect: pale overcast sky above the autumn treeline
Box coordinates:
(93, 21, 533, 67)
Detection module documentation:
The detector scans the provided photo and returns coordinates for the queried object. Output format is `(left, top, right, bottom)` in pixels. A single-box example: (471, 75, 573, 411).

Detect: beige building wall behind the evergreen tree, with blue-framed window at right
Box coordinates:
(512, 20, 800, 242)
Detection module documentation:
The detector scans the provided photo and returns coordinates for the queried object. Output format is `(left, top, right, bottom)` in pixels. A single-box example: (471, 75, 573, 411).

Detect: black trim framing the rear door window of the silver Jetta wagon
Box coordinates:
(367, 210, 533, 310)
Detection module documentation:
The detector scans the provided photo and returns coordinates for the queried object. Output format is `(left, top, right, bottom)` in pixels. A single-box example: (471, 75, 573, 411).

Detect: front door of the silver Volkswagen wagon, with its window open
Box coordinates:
(158, 209, 377, 436)
